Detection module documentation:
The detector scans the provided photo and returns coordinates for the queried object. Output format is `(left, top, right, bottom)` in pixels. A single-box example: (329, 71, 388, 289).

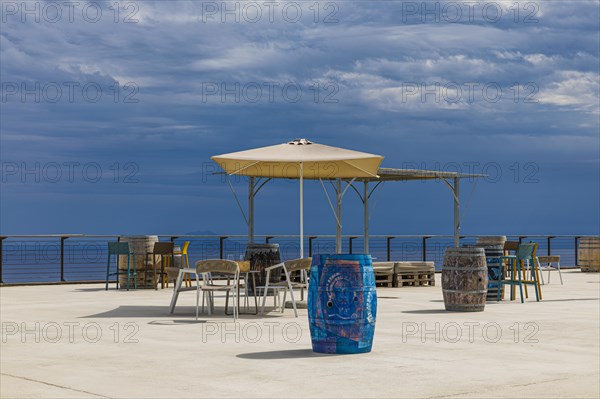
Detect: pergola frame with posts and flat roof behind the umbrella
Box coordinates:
(229, 168, 485, 253)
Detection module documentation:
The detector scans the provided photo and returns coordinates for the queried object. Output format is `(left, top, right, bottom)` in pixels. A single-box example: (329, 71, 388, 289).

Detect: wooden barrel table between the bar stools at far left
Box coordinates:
(119, 236, 160, 289)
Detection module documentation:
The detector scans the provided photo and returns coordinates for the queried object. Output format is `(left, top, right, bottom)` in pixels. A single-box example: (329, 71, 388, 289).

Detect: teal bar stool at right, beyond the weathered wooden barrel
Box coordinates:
(498, 242, 542, 303)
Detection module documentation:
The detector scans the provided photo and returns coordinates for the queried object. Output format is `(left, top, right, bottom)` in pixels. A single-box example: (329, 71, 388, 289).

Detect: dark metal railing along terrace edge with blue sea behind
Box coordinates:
(0, 234, 586, 285)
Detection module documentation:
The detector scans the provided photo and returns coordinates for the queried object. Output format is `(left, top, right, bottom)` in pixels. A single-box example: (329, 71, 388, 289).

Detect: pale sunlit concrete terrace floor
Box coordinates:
(0, 270, 600, 398)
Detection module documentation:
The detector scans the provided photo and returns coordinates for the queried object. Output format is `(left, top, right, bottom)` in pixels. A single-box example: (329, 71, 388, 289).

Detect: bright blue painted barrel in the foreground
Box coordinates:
(308, 254, 377, 354)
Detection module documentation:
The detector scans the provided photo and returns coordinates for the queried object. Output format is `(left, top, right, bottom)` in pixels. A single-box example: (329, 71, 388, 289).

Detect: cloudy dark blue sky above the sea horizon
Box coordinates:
(0, 0, 600, 235)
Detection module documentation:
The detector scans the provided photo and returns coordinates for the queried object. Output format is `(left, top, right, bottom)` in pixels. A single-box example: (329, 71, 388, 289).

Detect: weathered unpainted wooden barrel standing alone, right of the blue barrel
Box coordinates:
(442, 248, 488, 312)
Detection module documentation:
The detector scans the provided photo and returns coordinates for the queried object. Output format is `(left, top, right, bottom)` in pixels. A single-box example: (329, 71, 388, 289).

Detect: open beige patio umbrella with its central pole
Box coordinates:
(211, 139, 383, 257)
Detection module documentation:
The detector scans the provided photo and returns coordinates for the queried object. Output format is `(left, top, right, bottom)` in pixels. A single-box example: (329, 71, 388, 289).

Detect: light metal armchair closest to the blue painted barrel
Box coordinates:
(260, 258, 312, 317)
